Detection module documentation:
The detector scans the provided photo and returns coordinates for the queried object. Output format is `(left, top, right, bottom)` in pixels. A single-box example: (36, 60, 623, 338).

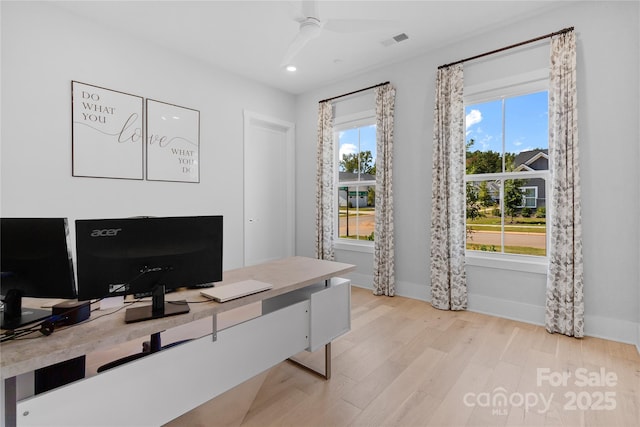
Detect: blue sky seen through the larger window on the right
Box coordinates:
(465, 92, 549, 153)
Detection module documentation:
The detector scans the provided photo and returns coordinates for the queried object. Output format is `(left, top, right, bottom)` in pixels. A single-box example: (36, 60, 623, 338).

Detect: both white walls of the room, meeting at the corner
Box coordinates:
(0, 2, 640, 348)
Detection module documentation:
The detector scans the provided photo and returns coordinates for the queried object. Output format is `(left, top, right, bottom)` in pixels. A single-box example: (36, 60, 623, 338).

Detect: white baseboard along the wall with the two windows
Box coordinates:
(348, 273, 640, 353)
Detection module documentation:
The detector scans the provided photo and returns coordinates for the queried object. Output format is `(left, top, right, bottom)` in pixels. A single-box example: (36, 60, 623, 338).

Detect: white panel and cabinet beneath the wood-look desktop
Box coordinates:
(10, 278, 351, 426)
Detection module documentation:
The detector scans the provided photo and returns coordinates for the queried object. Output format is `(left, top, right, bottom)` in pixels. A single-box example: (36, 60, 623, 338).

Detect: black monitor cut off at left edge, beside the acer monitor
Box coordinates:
(0, 218, 76, 329)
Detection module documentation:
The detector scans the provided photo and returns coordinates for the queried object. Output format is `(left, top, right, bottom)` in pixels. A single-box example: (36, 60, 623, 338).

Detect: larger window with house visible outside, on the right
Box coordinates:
(465, 90, 549, 257)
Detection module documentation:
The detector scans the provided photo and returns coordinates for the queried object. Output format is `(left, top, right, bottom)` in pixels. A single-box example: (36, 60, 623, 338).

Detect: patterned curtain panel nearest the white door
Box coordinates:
(316, 101, 335, 261)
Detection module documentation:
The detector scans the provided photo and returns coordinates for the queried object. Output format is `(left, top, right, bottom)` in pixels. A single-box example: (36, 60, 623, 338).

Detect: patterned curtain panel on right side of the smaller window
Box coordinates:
(373, 84, 396, 296)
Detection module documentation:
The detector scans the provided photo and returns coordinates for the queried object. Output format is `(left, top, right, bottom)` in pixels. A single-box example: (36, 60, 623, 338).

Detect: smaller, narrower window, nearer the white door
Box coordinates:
(334, 112, 376, 247)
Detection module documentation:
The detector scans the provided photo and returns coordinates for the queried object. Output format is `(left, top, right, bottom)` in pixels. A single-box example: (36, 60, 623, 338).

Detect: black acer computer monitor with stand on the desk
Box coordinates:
(76, 216, 222, 322)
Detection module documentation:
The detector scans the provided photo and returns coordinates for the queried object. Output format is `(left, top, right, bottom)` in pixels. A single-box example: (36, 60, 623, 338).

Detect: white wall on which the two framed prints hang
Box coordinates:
(1, 2, 295, 269)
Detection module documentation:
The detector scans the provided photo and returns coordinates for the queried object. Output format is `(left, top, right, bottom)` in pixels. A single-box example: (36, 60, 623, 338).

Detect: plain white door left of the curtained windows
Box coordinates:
(244, 111, 295, 266)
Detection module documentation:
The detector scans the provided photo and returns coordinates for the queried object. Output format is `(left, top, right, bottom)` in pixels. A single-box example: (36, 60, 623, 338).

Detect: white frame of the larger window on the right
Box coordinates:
(464, 68, 552, 274)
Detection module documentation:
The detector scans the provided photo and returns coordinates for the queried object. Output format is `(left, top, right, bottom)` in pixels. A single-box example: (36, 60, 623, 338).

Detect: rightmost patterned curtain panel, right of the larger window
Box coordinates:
(545, 31, 584, 337)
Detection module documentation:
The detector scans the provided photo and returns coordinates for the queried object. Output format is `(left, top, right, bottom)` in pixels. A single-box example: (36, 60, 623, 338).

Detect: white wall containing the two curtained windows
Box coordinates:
(296, 2, 640, 345)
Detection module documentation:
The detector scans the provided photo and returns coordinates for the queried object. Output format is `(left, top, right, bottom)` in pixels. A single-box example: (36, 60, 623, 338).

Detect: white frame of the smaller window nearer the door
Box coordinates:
(333, 109, 377, 254)
